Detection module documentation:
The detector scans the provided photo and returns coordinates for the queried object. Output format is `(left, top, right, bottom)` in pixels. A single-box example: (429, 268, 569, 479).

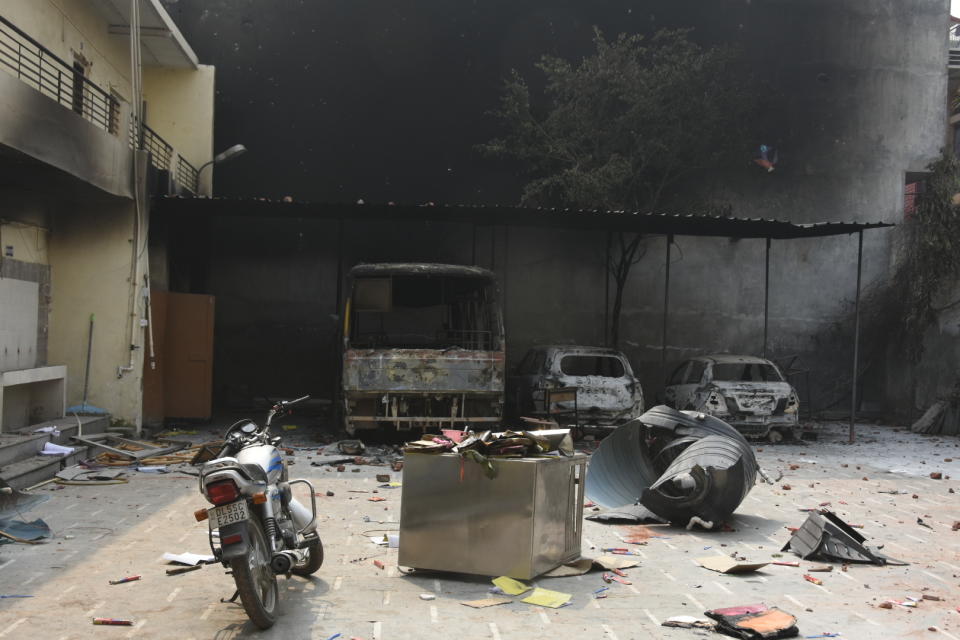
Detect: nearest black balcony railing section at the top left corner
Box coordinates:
(0, 16, 120, 134)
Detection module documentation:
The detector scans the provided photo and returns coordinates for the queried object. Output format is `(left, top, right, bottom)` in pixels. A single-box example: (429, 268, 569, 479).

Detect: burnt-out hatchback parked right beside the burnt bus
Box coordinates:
(507, 345, 643, 426)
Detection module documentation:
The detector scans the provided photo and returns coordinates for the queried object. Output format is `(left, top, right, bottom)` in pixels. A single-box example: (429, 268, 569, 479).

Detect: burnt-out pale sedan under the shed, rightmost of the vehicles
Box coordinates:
(664, 355, 800, 442)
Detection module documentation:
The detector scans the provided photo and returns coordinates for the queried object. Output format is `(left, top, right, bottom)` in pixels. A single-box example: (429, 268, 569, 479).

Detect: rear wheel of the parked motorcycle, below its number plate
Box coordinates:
(230, 520, 280, 629)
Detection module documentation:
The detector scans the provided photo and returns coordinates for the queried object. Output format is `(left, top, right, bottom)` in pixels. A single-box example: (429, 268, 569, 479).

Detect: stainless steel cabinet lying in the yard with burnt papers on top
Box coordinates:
(399, 453, 587, 580)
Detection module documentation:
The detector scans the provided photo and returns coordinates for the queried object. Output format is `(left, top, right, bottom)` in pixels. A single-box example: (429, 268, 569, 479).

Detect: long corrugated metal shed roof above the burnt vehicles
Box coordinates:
(154, 196, 894, 239)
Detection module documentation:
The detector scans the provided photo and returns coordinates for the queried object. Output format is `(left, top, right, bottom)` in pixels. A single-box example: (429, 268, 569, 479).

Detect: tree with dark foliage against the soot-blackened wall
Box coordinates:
(481, 29, 757, 346)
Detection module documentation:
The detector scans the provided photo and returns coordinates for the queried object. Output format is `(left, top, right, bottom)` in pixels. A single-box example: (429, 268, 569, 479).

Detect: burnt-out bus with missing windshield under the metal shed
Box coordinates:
(341, 263, 505, 434)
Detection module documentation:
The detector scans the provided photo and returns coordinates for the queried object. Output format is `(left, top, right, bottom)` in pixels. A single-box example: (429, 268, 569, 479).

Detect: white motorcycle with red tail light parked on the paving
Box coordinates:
(194, 396, 323, 629)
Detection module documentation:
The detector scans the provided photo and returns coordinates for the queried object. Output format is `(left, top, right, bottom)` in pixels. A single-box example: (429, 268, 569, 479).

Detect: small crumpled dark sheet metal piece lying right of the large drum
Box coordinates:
(782, 509, 906, 565)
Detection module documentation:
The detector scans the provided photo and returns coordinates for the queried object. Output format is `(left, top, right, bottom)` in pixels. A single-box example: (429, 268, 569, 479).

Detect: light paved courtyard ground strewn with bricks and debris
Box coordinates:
(0, 425, 960, 640)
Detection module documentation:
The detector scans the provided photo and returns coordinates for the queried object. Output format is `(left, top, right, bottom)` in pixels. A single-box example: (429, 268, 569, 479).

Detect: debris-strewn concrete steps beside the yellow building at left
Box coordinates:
(0, 416, 110, 489)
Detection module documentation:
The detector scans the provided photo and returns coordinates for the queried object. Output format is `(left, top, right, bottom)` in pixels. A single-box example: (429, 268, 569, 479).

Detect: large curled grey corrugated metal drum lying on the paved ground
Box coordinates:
(586, 405, 758, 528)
